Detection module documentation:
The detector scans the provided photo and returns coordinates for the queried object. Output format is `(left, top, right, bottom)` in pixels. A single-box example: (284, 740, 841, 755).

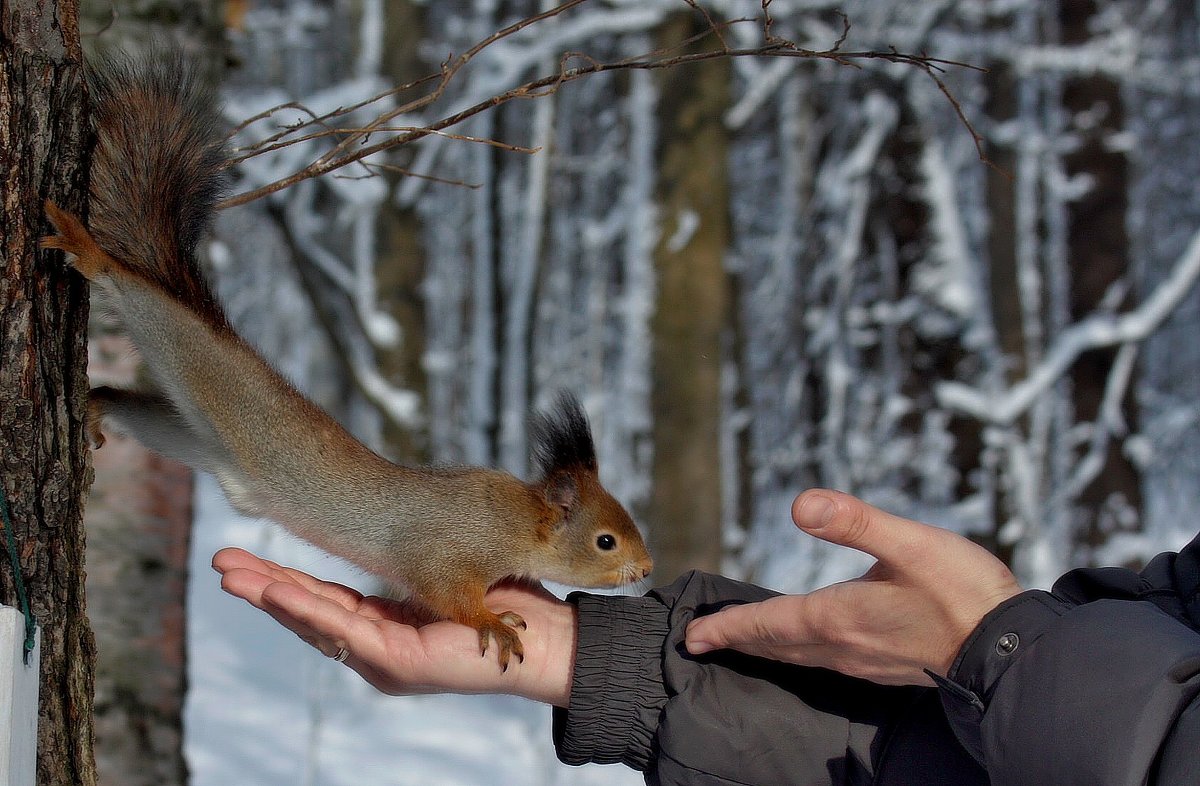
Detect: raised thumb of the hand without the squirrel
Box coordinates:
(792, 488, 942, 562)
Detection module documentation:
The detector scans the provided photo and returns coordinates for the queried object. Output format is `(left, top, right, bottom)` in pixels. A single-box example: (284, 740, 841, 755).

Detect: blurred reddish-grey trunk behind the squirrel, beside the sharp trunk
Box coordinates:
(86, 343, 192, 786)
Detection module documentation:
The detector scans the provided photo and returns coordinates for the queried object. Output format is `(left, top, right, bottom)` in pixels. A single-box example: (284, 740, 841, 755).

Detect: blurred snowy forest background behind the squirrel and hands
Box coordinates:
(77, 0, 1200, 786)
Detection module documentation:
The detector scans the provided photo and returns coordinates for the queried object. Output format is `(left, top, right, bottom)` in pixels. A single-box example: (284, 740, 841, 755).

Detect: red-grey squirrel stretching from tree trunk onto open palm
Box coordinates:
(42, 58, 653, 670)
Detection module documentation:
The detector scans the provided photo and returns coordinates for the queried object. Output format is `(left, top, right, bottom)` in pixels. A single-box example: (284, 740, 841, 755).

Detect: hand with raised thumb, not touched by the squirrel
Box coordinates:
(686, 490, 1021, 685)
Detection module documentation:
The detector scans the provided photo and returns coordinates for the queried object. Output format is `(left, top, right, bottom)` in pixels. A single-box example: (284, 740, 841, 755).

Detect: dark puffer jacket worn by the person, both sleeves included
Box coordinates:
(554, 538, 1200, 786)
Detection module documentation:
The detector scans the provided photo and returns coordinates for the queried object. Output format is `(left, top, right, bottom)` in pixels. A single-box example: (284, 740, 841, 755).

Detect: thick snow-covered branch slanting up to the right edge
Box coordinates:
(936, 223, 1200, 426)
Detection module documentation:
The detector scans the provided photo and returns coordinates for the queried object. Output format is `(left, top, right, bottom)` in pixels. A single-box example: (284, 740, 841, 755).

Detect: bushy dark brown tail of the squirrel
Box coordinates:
(88, 52, 227, 328)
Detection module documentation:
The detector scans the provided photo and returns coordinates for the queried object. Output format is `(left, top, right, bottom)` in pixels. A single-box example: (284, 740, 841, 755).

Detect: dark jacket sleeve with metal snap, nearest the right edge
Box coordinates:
(941, 539, 1200, 786)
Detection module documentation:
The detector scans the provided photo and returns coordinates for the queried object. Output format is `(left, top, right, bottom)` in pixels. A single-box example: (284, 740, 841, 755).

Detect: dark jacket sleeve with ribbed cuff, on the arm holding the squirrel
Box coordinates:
(554, 572, 988, 786)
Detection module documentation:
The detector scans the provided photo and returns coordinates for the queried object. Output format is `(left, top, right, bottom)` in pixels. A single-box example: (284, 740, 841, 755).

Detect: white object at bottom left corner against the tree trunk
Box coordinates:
(0, 606, 42, 786)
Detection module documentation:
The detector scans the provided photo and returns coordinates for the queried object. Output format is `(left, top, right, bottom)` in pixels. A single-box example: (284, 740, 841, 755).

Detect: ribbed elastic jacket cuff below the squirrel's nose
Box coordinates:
(553, 593, 670, 770)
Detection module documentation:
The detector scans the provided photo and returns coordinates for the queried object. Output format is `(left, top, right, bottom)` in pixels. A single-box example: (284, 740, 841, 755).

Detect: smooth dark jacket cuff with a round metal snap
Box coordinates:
(930, 589, 1073, 762)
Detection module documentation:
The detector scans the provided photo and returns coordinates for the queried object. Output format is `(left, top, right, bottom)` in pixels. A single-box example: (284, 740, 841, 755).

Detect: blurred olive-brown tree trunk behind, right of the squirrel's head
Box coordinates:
(649, 17, 731, 577)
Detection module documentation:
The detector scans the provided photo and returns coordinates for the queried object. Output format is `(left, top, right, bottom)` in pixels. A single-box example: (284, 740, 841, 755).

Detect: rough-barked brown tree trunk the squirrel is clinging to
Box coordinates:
(0, 0, 96, 786)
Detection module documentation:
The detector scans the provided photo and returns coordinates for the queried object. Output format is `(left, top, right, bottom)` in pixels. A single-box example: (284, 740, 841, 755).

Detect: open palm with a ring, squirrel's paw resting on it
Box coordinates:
(212, 548, 576, 707)
